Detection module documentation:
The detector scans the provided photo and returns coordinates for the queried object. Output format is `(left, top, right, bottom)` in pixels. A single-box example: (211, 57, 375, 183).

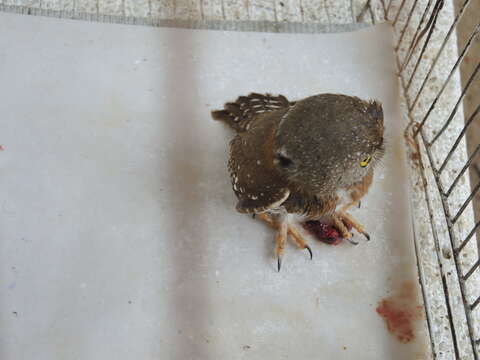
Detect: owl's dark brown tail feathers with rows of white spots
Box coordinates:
(212, 93, 292, 132)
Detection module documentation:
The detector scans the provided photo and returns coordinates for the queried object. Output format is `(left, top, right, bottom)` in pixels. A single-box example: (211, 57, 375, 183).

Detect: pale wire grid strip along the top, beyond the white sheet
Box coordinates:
(0, 0, 378, 33)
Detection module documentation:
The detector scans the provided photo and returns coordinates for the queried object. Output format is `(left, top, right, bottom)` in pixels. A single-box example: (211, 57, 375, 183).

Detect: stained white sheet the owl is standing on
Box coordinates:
(0, 14, 426, 360)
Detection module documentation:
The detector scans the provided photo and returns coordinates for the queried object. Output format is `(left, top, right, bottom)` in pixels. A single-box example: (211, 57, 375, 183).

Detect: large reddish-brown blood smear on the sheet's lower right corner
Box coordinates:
(376, 283, 422, 343)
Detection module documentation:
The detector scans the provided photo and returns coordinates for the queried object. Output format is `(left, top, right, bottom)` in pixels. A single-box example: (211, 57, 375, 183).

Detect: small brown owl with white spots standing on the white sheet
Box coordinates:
(212, 93, 384, 270)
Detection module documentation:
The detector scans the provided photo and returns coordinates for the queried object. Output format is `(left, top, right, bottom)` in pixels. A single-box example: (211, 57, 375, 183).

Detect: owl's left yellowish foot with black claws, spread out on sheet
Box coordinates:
(257, 213, 313, 271)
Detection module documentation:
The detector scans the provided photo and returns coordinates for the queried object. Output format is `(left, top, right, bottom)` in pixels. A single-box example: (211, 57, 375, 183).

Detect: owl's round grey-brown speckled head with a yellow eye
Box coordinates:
(273, 94, 384, 194)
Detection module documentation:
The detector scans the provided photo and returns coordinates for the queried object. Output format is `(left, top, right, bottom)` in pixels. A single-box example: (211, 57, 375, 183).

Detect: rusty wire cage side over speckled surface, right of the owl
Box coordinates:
(380, 0, 480, 360)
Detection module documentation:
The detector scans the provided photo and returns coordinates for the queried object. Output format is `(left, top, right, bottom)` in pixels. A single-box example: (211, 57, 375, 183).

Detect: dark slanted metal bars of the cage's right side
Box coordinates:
(387, 0, 480, 360)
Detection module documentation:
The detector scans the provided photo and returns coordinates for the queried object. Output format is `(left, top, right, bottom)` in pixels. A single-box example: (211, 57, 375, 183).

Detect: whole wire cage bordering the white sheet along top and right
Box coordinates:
(0, 0, 480, 360)
